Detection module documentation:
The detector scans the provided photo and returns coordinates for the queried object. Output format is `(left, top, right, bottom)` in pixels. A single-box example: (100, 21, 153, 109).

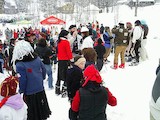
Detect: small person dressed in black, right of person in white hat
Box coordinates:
(94, 38, 106, 71)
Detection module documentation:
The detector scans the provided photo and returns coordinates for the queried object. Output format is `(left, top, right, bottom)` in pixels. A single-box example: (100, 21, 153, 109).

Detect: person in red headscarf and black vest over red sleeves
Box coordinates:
(69, 65, 117, 120)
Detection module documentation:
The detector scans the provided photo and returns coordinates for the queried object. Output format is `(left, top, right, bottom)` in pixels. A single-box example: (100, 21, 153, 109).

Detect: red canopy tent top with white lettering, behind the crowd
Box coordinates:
(40, 16, 66, 25)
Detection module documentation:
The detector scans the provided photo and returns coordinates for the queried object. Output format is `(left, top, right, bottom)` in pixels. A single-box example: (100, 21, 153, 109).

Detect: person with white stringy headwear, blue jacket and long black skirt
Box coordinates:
(12, 40, 51, 120)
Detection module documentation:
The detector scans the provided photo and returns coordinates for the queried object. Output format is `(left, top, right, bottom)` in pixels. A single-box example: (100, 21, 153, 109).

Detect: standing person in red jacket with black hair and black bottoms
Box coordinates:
(55, 30, 73, 97)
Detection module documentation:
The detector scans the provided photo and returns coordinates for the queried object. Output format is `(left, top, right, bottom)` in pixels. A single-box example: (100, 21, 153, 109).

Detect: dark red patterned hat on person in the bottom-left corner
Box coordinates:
(0, 76, 19, 97)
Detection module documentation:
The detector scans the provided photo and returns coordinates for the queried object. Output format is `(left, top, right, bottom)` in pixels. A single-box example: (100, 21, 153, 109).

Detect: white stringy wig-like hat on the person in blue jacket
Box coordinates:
(12, 40, 34, 70)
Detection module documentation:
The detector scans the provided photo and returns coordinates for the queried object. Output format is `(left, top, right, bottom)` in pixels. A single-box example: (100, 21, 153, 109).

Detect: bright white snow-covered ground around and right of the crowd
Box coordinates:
(0, 5, 160, 120)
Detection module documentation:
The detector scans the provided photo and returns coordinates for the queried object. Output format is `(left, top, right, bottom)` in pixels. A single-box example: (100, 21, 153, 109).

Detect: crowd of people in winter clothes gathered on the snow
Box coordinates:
(0, 20, 155, 120)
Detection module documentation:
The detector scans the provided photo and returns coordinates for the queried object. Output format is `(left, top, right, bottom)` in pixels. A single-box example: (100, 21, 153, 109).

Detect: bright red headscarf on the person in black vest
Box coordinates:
(82, 65, 102, 87)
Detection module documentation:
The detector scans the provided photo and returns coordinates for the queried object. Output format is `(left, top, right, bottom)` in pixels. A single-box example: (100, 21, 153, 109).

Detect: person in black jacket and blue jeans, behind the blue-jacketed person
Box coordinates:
(35, 38, 53, 89)
